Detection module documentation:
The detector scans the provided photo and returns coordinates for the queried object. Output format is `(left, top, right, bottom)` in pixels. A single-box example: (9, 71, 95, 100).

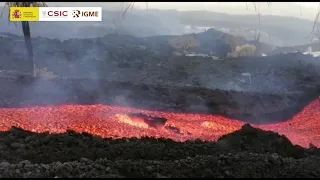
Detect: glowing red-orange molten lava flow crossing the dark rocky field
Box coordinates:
(0, 99, 320, 147)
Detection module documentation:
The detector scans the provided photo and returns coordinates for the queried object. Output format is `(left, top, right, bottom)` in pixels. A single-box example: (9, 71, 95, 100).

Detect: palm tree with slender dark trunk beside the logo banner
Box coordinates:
(1, 2, 47, 77)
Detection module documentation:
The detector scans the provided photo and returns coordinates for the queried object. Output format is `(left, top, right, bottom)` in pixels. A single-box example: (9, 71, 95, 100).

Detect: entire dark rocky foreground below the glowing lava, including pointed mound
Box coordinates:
(0, 125, 320, 178)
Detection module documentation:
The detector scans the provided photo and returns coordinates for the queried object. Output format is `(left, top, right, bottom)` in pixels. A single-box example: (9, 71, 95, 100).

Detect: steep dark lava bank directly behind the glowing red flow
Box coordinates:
(0, 78, 320, 124)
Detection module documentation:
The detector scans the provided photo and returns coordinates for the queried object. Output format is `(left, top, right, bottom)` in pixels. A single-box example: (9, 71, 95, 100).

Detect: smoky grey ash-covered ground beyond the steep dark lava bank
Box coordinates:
(0, 30, 320, 94)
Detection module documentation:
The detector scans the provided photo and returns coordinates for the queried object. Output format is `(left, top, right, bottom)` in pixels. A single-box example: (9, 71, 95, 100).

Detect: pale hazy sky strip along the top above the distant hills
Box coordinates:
(0, 2, 319, 20)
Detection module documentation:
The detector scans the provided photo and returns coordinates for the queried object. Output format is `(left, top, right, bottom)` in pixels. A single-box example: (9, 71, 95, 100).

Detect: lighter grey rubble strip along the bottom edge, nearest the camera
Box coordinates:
(0, 152, 320, 178)
